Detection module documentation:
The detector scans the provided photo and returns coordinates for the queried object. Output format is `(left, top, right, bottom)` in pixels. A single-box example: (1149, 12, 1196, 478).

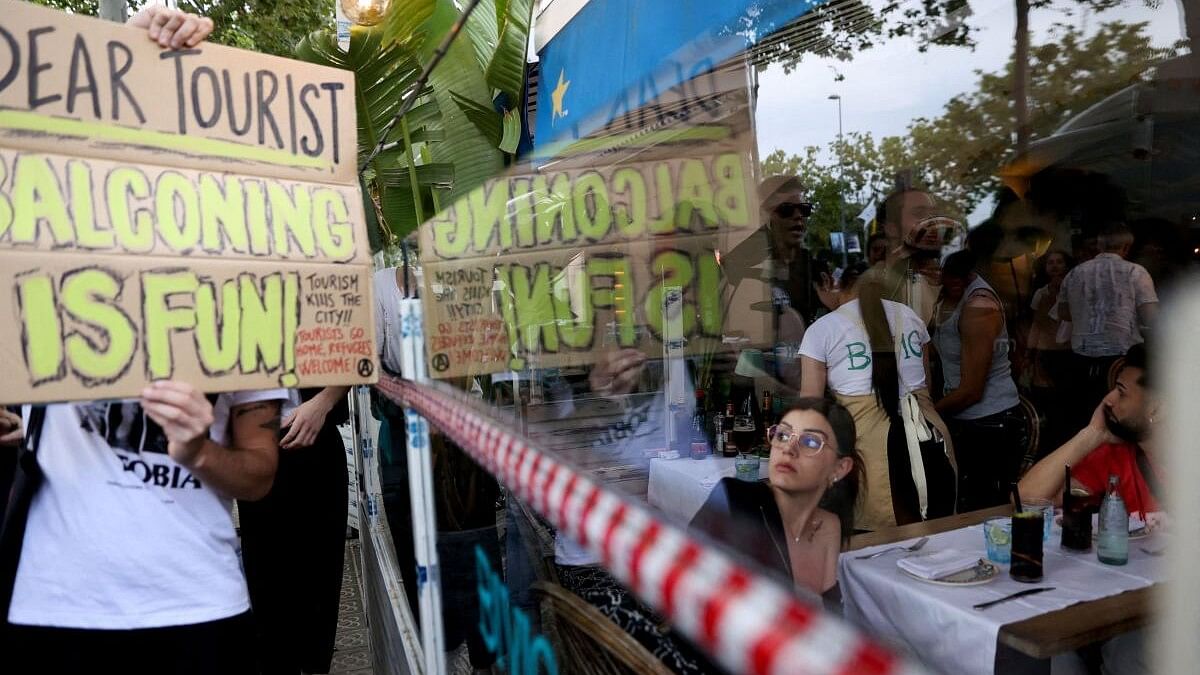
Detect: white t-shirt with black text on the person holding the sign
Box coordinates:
(8, 389, 288, 629)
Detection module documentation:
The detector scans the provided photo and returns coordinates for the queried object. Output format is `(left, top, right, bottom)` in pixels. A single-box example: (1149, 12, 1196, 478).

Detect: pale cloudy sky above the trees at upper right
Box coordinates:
(756, 0, 1184, 189)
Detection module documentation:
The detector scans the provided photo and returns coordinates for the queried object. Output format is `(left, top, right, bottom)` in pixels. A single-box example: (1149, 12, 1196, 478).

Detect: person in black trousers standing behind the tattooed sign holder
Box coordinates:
(238, 387, 349, 675)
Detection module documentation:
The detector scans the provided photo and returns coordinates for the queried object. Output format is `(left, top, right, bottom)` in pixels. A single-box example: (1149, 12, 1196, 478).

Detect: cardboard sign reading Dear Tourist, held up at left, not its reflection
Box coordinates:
(0, 1, 377, 404)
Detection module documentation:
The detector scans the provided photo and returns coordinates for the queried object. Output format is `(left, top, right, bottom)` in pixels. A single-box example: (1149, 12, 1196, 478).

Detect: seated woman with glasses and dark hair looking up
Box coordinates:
(691, 399, 862, 598)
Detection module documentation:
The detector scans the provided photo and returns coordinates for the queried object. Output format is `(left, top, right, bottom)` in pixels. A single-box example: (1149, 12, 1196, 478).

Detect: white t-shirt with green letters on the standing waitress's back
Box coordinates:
(800, 299, 929, 396)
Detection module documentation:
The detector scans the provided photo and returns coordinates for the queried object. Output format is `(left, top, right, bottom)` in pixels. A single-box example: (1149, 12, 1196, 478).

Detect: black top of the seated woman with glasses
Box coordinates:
(689, 478, 841, 611)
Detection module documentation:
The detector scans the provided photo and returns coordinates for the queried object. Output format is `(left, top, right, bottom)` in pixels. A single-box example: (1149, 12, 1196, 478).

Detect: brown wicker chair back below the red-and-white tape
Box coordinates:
(533, 581, 671, 675)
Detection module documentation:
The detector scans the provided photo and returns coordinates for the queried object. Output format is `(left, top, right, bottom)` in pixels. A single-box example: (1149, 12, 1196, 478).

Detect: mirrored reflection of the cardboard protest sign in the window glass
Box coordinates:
(420, 61, 770, 377)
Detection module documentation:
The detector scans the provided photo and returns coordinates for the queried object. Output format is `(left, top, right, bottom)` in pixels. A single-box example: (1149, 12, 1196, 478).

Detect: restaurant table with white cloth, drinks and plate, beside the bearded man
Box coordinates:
(839, 506, 1164, 671)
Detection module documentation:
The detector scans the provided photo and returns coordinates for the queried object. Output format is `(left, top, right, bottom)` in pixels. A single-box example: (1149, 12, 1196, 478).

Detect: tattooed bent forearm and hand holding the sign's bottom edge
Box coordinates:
(142, 381, 280, 501)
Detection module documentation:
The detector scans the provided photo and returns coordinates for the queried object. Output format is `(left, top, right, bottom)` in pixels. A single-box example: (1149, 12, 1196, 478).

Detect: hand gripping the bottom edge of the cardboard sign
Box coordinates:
(142, 380, 212, 468)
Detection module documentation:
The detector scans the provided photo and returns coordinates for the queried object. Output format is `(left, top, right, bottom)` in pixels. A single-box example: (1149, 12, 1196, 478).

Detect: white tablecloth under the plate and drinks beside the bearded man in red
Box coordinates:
(838, 525, 1165, 675)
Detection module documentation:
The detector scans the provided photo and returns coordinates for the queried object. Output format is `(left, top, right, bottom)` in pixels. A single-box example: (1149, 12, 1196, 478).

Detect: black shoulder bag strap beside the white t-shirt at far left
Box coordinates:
(0, 406, 46, 626)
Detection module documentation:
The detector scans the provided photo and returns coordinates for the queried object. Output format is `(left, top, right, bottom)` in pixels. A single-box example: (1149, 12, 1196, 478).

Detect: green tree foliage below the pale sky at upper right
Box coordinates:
(763, 23, 1174, 220)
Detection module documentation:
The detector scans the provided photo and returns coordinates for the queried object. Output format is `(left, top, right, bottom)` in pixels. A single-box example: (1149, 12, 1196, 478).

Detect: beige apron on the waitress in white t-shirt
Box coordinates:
(836, 389, 958, 530)
